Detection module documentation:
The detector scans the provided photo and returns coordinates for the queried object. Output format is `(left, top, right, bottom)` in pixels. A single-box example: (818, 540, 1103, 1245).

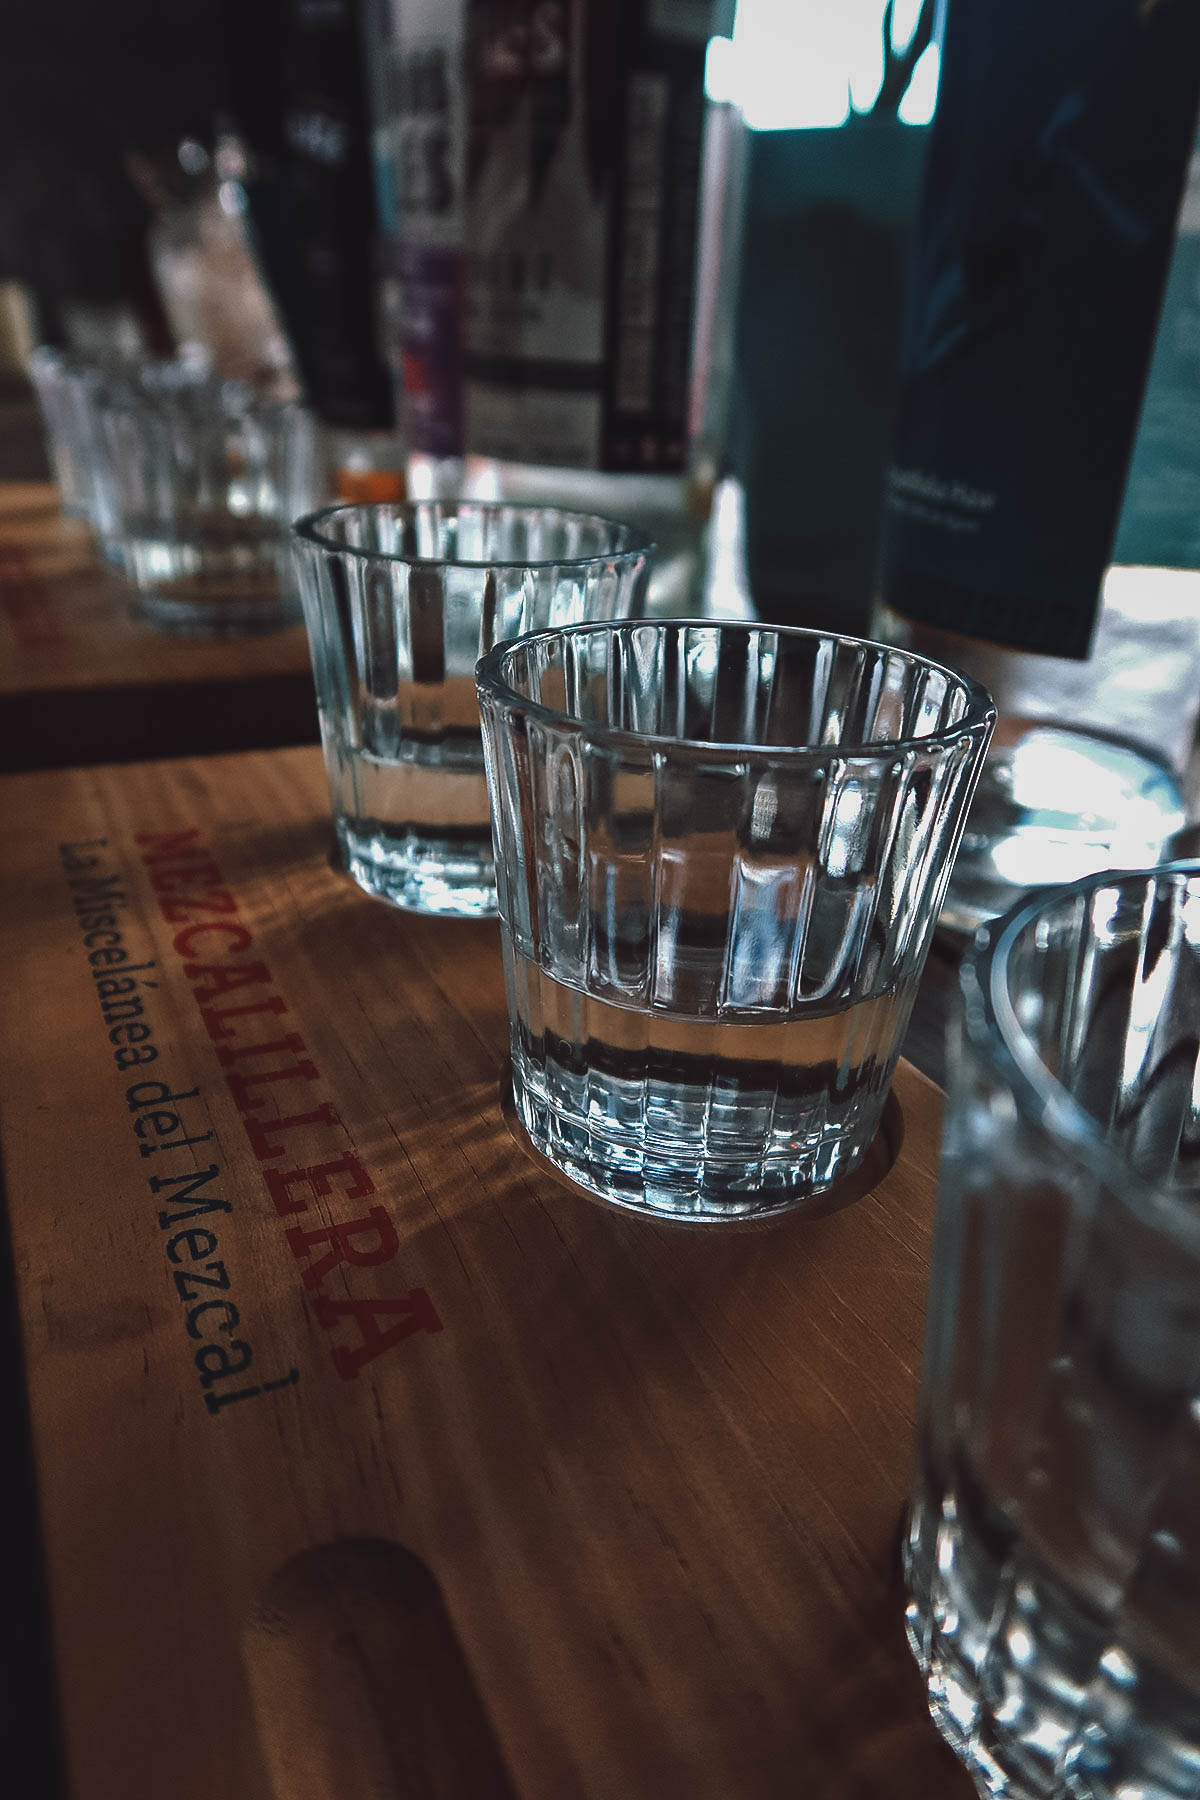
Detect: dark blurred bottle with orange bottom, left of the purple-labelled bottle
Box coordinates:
(225, 0, 405, 500)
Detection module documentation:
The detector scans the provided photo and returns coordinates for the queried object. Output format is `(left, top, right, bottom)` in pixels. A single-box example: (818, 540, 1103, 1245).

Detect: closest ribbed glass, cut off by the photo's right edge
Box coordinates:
(905, 862, 1200, 1800)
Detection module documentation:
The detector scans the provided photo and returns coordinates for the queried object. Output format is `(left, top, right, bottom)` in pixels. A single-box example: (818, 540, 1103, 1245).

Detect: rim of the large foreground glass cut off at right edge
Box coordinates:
(959, 857, 1200, 1209)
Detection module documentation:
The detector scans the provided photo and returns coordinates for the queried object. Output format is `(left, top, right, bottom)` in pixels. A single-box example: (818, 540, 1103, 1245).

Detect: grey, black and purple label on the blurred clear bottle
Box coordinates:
(379, 0, 712, 472)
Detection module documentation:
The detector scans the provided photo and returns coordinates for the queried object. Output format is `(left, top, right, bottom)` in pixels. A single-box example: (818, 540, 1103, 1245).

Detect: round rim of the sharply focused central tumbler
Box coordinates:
(475, 617, 997, 763)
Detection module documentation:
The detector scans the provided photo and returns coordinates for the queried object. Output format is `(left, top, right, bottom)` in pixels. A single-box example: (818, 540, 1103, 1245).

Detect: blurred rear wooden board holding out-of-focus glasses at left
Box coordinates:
(0, 482, 317, 769)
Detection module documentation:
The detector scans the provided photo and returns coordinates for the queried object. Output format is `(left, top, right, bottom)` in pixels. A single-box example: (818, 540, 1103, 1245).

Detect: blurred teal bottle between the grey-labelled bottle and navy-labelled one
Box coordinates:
(727, 0, 937, 632)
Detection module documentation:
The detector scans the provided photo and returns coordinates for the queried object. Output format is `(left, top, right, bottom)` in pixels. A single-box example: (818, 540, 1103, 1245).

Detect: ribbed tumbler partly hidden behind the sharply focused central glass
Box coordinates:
(295, 514, 653, 916)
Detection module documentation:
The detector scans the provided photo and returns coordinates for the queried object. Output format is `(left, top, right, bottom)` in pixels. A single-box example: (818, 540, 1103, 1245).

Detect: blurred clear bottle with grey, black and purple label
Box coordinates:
(372, 0, 739, 612)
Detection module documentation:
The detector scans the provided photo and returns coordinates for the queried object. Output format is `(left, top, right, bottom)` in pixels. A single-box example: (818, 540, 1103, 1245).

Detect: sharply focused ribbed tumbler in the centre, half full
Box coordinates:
(477, 623, 993, 1222)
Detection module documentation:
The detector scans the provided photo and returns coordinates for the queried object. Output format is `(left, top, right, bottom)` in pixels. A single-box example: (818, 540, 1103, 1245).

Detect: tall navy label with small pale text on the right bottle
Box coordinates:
(880, 0, 1200, 657)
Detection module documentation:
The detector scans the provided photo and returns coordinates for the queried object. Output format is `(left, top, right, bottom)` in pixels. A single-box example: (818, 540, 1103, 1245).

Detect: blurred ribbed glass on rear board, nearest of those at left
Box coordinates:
(92, 360, 318, 635)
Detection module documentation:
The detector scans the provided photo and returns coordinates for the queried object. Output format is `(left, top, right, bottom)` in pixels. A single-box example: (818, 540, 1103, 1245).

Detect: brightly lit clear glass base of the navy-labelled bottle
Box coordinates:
(937, 725, 1186, 932)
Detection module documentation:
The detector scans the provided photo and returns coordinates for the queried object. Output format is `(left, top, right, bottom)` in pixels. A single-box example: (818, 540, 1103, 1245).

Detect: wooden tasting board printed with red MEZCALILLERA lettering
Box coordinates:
(0, 751, 972, 1800)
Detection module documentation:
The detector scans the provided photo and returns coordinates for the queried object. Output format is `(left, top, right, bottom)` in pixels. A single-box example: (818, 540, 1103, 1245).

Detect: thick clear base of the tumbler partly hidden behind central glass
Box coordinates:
(336, 819, 497, 918)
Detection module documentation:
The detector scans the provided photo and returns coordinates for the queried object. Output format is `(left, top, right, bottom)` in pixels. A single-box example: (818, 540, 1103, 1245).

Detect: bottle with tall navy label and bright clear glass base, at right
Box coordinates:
(874, 0, 1200, 929)
